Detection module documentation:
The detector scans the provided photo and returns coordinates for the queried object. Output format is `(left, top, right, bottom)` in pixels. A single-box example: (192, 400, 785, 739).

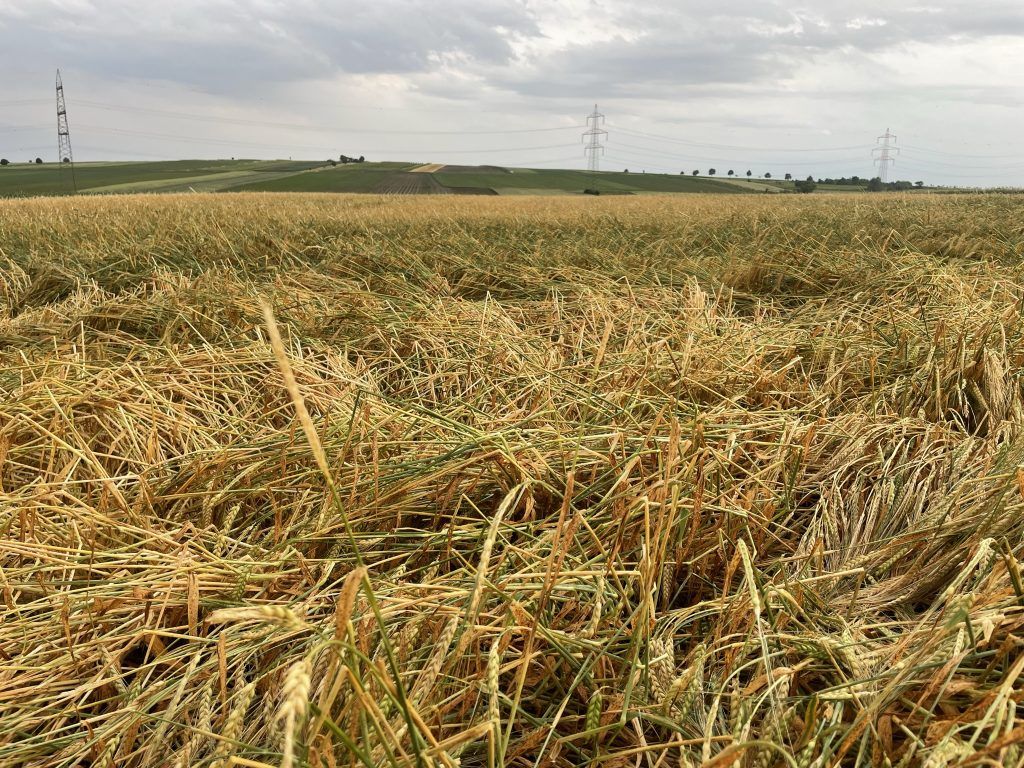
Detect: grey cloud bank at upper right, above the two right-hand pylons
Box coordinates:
(477, 0, 1024, 97)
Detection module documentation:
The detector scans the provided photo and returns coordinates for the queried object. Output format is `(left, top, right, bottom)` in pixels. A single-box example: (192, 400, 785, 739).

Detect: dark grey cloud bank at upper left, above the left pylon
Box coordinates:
(0, 0, 539, 90)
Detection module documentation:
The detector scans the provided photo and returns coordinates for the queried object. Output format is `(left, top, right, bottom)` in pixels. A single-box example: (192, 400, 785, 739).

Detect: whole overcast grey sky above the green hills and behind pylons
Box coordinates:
(0, 0, 1024, 185)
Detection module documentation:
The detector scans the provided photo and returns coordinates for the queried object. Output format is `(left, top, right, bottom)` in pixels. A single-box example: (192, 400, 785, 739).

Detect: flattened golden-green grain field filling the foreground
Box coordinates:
(0, 194, 1024, 768)
